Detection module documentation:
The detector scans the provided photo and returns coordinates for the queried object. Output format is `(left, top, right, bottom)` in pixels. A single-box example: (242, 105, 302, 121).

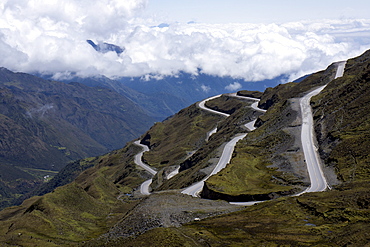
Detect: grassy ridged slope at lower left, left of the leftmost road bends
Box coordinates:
(0, 145, 145, 246)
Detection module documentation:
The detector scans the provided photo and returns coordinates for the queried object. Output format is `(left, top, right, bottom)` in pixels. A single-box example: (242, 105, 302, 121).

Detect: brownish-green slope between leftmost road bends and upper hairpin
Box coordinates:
(143, 105, 222, 168)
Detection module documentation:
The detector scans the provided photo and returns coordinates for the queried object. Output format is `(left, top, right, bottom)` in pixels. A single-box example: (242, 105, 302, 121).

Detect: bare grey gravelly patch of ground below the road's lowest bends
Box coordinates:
(87, 191, 244, 246)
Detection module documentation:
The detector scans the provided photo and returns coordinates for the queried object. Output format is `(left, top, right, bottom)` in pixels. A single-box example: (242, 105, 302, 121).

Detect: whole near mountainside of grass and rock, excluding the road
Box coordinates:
(0, 52, 370, 246)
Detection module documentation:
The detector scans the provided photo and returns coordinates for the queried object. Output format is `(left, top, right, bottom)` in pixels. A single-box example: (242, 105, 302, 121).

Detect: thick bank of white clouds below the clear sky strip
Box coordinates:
(0, 0, 370, 83)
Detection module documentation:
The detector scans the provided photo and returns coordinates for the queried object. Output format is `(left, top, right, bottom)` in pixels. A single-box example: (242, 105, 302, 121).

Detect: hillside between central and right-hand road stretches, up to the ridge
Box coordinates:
(202, 61, 342, 201)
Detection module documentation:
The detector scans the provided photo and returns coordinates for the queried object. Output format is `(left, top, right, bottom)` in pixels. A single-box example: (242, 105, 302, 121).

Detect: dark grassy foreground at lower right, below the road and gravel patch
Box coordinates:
(124, 182, 370, 246)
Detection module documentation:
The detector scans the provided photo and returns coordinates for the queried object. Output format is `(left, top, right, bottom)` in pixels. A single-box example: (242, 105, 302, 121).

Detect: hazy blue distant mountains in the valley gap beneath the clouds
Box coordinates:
(42, 72, 287, 121)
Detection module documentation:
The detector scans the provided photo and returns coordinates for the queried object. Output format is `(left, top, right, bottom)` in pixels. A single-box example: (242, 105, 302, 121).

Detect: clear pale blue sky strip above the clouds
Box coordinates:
(147, 0, 370, 24)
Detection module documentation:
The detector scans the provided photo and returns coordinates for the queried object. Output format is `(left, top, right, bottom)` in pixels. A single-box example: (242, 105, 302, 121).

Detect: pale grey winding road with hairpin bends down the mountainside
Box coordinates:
(135, 61, 346, 201)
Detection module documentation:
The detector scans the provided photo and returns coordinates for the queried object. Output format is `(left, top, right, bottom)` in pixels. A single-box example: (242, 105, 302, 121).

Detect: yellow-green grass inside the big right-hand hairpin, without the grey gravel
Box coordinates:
(206, 102, 301, 200)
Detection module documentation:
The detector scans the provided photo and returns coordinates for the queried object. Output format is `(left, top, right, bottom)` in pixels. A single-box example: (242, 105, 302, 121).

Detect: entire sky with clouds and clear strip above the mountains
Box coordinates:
(0, 0, 370, 81)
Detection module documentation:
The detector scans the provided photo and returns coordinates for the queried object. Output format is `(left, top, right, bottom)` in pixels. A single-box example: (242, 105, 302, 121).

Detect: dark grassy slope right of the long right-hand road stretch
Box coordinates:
(313, 52, 370, 181)
